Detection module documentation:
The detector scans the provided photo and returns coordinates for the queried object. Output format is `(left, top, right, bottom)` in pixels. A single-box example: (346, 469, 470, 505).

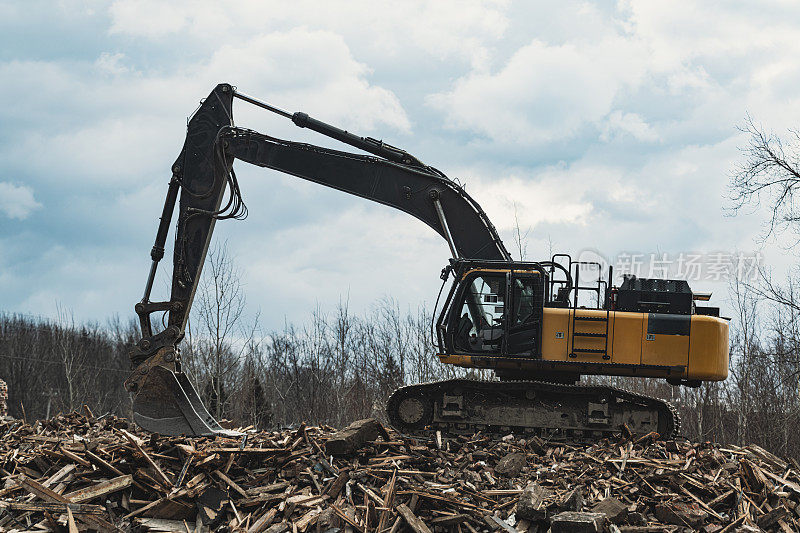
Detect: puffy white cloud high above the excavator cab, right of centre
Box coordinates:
(429, 37, 647, 145)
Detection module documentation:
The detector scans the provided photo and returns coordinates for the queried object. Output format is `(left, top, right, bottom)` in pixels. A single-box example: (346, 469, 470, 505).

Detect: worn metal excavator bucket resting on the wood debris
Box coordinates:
(128, 354, 241, 437)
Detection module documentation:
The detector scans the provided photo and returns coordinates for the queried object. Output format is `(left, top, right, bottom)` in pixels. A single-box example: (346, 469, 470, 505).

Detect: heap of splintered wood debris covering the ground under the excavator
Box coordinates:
(0, 412, 800, 533)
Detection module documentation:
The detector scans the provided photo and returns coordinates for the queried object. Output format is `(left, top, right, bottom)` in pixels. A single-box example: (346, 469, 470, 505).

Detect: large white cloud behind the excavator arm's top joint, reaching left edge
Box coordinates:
(0, 28, 411, 190)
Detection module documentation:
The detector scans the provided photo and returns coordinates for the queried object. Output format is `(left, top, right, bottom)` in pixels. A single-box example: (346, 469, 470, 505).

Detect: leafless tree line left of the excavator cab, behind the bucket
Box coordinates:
(0, 293, 488, 429)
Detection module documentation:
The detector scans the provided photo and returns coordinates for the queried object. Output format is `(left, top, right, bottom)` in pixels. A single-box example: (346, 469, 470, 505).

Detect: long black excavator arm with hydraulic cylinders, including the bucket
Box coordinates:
(125, 84, 511, 435)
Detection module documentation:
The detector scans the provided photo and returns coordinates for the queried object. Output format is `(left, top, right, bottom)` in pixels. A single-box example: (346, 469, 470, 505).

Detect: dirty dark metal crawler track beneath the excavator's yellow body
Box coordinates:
(386, 379, 680, 441)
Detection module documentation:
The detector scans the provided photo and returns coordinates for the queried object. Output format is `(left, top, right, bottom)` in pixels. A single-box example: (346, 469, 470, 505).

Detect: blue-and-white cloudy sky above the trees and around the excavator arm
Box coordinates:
(0, 0, 800, 328)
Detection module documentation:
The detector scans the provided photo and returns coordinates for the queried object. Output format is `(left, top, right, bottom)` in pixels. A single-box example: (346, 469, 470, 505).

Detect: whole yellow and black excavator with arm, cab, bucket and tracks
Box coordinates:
(125, 84, 728, 439)
